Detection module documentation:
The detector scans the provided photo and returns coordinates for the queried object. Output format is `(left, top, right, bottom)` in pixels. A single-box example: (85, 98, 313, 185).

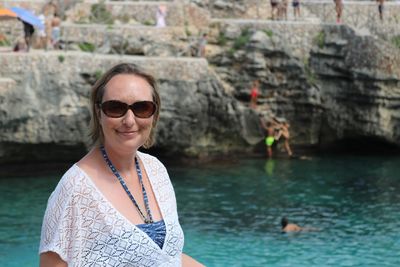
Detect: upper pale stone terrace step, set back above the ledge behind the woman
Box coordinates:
(62, 24, 197, 56)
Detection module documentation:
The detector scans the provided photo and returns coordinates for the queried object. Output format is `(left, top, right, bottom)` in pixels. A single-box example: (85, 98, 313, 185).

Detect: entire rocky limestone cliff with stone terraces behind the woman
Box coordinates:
(0, 0, 400, 163)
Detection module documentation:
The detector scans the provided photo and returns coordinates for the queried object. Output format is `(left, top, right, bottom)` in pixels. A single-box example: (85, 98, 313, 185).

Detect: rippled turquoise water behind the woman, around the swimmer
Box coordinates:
(0, 156, 400, 267)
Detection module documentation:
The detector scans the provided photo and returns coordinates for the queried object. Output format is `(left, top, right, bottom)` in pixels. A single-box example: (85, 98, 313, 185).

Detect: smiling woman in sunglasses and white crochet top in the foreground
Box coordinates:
(40, 64, 202, 267)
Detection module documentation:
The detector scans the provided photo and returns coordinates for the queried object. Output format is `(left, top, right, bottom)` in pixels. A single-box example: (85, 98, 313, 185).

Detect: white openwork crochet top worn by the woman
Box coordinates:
(39, 152, 184, 267)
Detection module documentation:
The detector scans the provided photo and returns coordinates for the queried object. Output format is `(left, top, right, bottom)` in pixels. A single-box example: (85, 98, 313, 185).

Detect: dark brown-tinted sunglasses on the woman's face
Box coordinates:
(99, 100, 157, 119)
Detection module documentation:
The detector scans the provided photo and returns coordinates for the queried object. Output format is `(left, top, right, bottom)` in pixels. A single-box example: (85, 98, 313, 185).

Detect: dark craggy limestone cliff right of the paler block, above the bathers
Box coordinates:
(210, 25, 400, 150)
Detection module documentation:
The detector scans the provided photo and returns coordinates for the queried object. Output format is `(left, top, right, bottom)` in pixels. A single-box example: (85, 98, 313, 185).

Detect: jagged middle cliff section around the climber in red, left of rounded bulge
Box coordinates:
(211, 29, 324, 145)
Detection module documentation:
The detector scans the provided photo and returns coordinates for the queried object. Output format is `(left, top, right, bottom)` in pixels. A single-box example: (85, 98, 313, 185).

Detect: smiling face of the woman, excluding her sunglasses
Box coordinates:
(99, 74, 154, 153)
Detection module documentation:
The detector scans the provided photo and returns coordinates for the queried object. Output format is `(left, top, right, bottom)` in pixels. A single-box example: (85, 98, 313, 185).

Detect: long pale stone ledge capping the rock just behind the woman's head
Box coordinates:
(0, 49, 209, 83)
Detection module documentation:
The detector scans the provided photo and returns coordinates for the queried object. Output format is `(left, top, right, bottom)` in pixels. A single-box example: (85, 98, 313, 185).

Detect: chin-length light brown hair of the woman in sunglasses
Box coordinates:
(89, 63, 161, 148)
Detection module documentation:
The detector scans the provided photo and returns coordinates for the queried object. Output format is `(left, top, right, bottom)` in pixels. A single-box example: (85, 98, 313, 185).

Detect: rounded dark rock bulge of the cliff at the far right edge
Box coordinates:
(310, 27, 400, 145)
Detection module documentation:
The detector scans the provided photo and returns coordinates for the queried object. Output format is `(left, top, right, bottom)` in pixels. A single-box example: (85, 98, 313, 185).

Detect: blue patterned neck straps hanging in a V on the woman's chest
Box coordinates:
(100, 146, 154, 223)
